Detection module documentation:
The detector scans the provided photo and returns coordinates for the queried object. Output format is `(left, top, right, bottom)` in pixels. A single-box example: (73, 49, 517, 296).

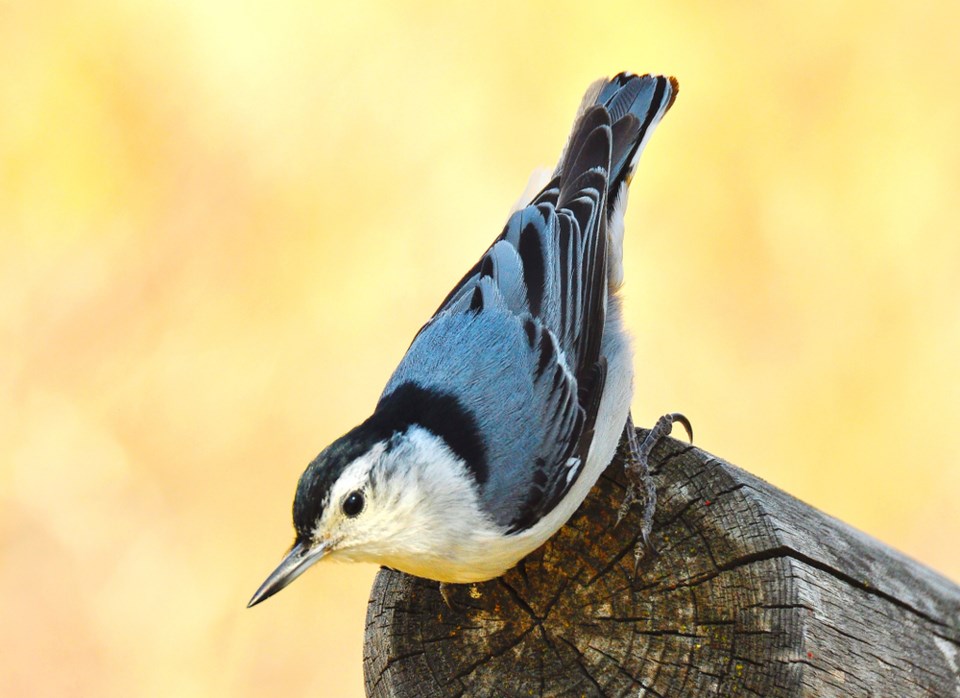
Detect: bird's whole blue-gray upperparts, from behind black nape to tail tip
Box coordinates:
(384, 75, 672, 531)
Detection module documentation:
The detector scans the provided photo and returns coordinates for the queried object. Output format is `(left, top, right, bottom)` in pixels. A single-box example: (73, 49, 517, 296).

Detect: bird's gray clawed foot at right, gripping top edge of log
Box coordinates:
(617, 412, 693, 569)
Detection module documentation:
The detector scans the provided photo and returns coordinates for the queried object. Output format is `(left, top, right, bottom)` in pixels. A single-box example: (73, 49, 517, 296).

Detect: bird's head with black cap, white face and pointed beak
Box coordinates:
(248, 386, 492, 606)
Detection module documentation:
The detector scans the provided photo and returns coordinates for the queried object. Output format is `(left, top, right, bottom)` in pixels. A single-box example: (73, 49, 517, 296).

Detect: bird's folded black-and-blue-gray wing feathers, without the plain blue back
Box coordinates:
(411, 107, 613, 531)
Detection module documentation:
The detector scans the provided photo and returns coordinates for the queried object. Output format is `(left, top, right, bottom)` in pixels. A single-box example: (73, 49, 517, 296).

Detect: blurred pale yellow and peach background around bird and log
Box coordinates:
(0, 0, 960, 696)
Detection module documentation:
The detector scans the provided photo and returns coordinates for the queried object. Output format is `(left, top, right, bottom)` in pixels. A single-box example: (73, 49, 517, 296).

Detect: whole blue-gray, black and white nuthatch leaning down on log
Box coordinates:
(248, 72, 692, 606)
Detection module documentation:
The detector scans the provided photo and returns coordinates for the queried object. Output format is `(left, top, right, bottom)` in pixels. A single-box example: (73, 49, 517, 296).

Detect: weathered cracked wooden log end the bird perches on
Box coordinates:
(364, 426, 960, 698)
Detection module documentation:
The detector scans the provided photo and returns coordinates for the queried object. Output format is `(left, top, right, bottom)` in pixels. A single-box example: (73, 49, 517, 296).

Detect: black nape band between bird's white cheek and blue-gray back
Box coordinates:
(370, 383, 490, 485)
